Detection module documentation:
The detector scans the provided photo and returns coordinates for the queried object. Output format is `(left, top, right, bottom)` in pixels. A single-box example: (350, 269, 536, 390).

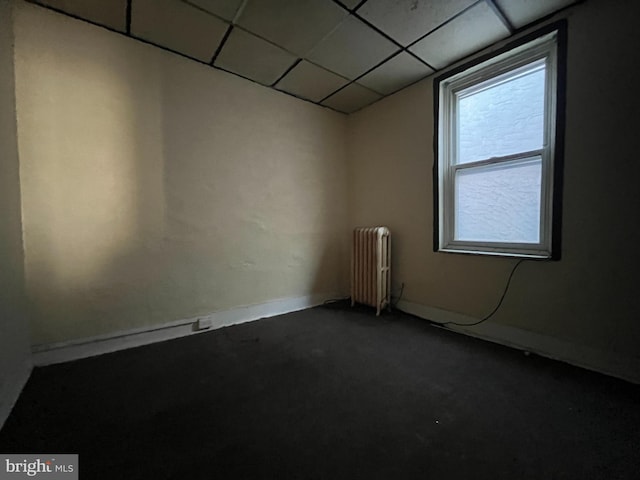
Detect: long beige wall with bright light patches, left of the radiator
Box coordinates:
(16, 4, 349, 344)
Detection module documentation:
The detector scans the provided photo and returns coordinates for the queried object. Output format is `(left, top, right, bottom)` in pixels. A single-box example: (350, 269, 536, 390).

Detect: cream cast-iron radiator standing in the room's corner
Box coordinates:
(351, 227, 391, 315)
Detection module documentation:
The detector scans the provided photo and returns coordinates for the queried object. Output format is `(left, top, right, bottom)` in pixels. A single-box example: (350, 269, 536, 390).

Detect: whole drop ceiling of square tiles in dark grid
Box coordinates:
(32, 0, 577, 113)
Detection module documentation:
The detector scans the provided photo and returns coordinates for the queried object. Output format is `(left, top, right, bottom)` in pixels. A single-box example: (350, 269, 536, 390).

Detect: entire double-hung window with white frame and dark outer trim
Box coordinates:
(434, 25, 564, 258)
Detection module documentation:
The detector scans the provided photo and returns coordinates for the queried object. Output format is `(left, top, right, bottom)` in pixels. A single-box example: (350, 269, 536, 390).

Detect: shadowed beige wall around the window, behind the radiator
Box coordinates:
(348, 0, 640, 379)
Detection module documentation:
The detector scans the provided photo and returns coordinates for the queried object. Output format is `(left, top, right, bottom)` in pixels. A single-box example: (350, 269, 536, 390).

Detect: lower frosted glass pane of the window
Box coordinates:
(455, 157, 542, 243)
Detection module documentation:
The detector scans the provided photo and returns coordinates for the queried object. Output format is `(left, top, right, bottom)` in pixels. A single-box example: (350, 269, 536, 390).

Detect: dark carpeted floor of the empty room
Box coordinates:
(0, 304, 640, 480)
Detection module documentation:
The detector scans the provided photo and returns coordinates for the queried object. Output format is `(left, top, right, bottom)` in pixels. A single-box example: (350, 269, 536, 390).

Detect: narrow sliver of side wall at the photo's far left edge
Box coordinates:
(0, 0, 31, 428)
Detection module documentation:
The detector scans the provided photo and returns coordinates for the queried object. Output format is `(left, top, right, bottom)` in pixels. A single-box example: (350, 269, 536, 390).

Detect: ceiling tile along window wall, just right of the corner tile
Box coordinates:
(358, 52, 433, 95)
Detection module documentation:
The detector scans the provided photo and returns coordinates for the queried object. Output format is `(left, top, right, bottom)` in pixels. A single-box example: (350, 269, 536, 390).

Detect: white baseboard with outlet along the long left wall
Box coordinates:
(32, 293, 341, 366)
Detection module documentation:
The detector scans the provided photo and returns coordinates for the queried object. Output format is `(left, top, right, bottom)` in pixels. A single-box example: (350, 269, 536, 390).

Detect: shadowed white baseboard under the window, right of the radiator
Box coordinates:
(397, 300, 640, 384)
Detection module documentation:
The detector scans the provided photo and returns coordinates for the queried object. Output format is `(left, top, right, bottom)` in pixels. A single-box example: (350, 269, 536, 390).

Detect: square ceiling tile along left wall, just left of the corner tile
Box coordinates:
(276, 60, 349, 102)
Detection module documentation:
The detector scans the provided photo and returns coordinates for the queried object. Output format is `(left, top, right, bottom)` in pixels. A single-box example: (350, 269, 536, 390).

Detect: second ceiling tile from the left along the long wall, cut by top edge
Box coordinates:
(131, 0, 228, 62)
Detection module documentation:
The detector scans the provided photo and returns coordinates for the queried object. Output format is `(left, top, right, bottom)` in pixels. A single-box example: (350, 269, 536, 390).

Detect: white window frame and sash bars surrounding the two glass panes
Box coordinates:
(434, 30, 559, 258)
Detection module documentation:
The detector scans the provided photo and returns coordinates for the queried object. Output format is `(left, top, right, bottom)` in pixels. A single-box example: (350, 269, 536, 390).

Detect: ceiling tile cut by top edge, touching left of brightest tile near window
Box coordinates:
(358, 0, 476, 45)
